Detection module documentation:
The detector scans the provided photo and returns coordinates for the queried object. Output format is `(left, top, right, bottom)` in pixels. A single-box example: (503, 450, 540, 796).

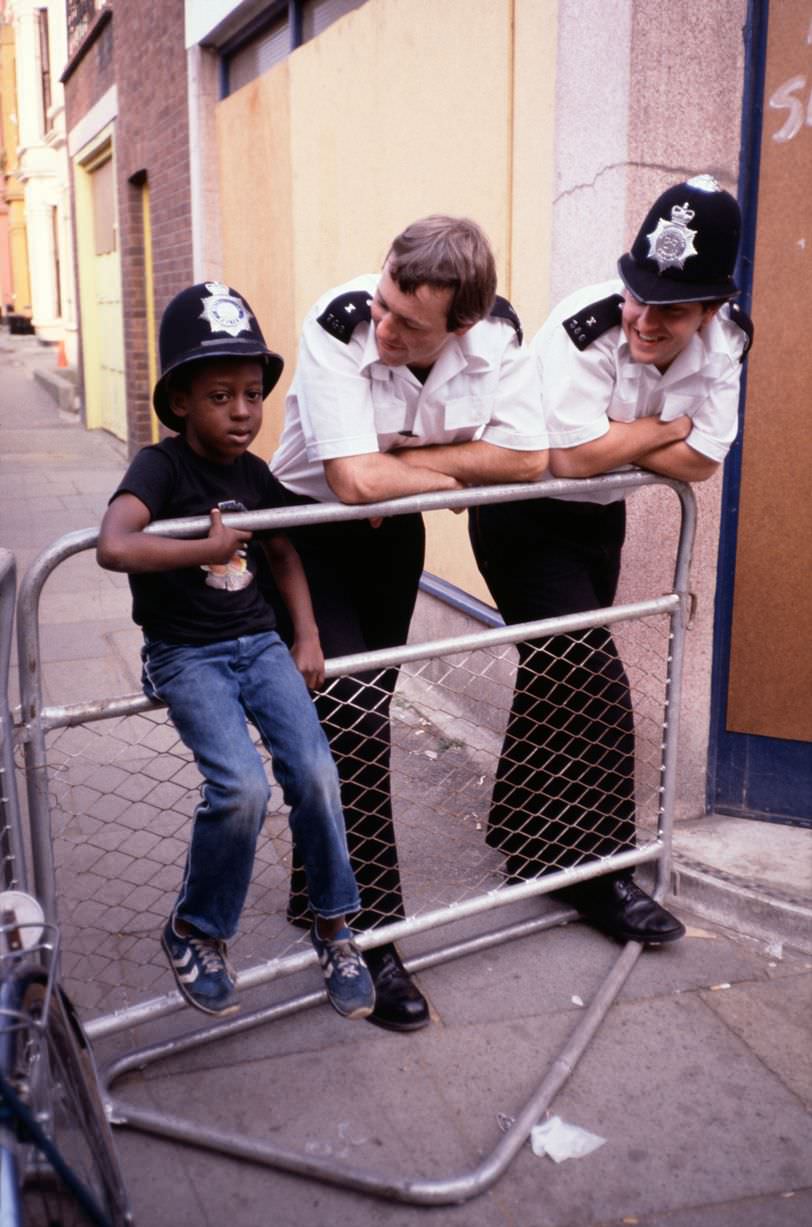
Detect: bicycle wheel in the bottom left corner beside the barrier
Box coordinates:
(16, 968, 132, 1227)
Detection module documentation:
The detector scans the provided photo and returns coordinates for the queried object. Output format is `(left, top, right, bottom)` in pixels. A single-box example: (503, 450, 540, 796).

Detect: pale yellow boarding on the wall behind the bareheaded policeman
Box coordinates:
(217, 0, 557, 594)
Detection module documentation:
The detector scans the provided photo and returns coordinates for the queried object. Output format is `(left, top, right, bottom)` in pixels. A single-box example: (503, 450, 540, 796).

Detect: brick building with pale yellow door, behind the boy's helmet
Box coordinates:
(63, 0, 191, 447)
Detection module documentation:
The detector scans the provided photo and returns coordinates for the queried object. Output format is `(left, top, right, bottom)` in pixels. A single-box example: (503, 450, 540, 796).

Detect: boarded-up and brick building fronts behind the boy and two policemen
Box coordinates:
(58, 0, 812, 817)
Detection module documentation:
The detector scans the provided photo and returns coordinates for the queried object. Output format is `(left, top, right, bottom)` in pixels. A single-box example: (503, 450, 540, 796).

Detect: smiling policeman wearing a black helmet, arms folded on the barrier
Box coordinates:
(470, 174, 752, 944)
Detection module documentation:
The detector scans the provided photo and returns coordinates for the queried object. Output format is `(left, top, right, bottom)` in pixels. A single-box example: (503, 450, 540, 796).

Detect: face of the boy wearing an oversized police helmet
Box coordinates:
(170, 358, 262, 464)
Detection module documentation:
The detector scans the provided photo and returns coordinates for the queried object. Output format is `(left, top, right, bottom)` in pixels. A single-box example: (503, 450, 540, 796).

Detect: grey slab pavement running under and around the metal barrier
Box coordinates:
(0, 331, 812, 1227)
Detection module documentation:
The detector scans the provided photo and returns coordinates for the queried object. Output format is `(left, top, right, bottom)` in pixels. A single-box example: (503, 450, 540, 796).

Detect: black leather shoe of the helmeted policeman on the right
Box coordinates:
(556, 875, 686, 945)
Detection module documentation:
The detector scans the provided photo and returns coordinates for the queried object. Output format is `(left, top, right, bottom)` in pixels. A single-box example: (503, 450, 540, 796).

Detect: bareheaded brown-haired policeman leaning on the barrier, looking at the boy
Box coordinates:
(271, 216, 547, 1031)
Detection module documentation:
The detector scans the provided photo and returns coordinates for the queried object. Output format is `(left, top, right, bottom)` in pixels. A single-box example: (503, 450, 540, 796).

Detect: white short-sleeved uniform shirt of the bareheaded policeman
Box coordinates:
(271, 274, 547, 502)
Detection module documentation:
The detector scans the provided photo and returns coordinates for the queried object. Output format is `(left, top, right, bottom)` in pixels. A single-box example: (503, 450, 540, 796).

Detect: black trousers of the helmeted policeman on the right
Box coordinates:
(469, 498, 634, 877)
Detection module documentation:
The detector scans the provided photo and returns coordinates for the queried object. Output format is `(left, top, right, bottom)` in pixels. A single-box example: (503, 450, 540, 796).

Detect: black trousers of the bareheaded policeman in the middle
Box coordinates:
(273, 510, 424, 929)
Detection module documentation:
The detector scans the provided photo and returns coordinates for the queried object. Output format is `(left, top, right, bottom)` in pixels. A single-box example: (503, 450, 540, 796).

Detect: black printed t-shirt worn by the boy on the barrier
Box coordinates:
(110, 436, 286, 643)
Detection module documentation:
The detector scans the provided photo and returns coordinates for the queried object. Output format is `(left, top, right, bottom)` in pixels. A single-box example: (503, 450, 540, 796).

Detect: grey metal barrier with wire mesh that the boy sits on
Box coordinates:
(9, 471, 695, 1205)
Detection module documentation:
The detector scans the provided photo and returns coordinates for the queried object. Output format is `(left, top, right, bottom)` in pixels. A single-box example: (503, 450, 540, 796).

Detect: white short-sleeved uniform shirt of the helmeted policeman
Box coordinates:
(530, 280, 747, 503)
